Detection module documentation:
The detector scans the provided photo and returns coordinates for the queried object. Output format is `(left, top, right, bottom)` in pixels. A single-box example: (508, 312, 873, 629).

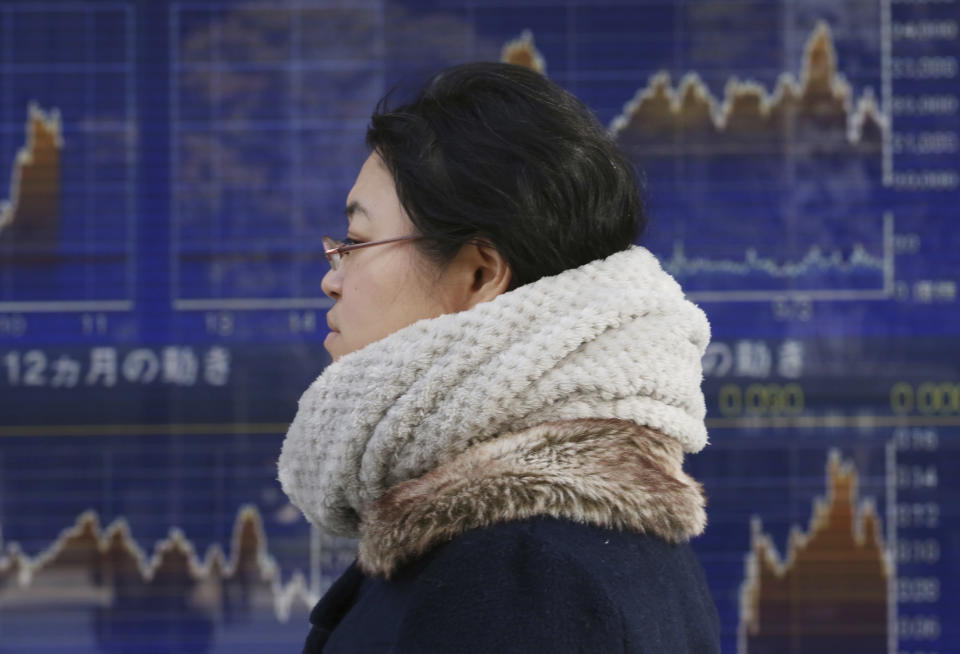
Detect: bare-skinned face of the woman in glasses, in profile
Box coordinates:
(322, 153, 465, 361)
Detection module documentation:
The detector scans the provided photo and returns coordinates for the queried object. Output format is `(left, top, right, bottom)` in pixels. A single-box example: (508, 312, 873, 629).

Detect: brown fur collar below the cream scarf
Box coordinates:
(359, 419, 706, 577)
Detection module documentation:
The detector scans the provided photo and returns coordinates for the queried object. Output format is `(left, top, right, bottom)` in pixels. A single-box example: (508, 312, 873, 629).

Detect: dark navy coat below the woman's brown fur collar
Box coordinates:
(304, 517, 720, 654)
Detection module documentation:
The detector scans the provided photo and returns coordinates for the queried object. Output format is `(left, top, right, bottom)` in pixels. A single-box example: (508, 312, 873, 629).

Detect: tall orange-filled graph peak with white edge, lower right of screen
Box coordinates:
(737, 450, 895, 654)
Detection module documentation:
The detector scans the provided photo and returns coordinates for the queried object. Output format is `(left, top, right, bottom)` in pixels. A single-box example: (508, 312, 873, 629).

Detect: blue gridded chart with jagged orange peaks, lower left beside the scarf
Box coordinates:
(0, 425, 355, 651)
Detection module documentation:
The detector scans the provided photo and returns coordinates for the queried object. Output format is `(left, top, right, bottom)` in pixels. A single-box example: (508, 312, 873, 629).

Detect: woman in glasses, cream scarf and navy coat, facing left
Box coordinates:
(279, 64, 719, 654)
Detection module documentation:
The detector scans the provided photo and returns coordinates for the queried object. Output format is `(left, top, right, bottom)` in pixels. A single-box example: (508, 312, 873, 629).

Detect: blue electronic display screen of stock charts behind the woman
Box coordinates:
(0, 0, 960, 654)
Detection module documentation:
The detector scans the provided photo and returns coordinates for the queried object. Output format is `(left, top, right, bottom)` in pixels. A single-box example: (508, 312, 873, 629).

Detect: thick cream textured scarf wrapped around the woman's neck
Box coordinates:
(279, 246, 710, 536)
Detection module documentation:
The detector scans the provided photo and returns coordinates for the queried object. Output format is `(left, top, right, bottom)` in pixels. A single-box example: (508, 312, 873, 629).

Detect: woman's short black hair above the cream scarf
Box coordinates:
(367, 63, 646, 287)
